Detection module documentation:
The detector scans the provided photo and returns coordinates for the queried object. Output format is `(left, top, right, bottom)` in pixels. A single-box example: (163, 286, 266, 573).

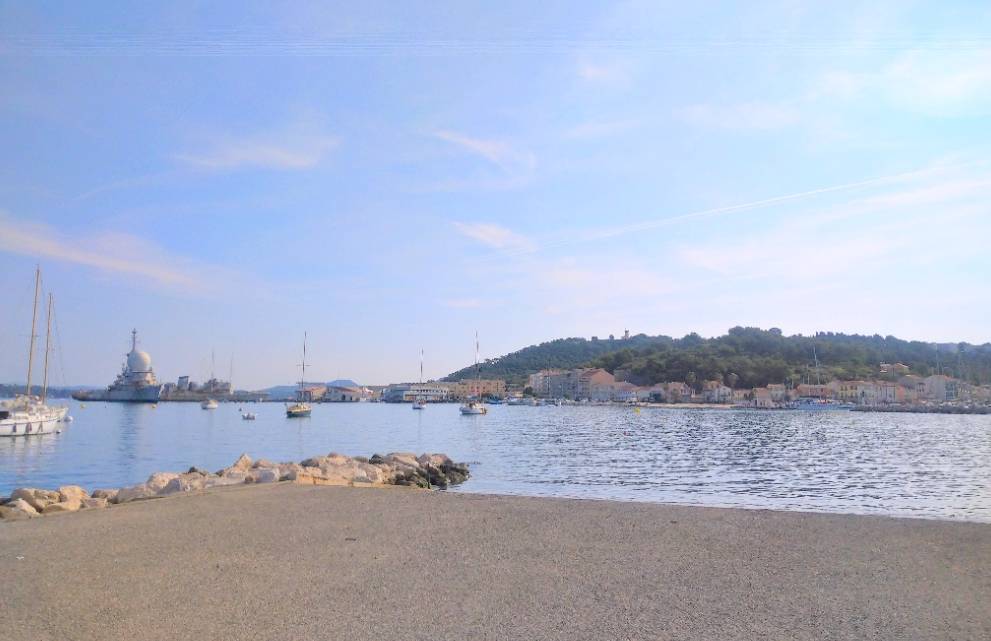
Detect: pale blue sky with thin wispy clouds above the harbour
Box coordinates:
(0, 0, 991, 388)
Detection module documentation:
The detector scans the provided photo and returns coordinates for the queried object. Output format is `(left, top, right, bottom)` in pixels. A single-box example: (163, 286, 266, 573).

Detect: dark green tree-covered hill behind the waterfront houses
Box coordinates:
(448, 327, 991, 387)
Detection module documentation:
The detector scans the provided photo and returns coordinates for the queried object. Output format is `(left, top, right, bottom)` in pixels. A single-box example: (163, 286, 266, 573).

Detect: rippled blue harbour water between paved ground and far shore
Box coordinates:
(0, 402, 991, 522)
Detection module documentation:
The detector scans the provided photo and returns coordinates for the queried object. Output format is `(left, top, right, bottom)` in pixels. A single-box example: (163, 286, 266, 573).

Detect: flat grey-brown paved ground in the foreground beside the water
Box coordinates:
(0, 484, 991, 641)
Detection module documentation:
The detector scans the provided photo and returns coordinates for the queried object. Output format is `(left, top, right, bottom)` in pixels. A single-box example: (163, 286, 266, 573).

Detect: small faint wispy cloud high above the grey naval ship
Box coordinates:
(175, 122, 339, 171)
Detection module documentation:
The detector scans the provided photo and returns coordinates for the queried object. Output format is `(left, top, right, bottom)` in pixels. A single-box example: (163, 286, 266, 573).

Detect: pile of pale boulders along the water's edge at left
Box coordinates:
(0, 452, 468, 519)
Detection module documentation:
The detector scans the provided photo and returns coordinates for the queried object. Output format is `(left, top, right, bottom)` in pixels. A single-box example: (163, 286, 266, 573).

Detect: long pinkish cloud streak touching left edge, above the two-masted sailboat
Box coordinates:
(0, 212, 225, 292)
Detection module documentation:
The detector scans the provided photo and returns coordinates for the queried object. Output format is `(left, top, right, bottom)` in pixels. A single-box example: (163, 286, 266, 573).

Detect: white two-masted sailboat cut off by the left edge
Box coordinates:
(0, 267, 72, 436)
